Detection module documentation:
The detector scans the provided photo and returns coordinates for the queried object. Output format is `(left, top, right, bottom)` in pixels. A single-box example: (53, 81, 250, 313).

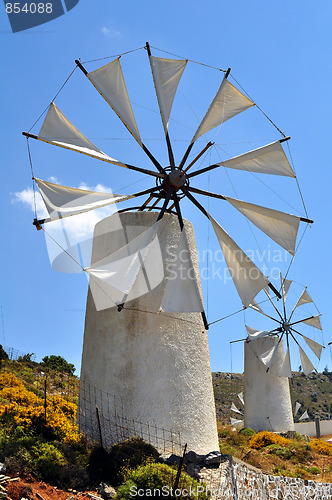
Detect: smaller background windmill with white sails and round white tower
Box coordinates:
(245, 277, 323, 431)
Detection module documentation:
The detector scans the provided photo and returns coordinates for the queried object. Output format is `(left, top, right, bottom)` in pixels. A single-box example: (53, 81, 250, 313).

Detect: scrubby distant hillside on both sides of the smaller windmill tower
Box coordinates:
(212, 372, 332, 423)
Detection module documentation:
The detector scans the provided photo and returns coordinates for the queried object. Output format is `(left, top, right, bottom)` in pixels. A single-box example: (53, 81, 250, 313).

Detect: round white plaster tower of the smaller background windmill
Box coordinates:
(244, 337, 294, 432)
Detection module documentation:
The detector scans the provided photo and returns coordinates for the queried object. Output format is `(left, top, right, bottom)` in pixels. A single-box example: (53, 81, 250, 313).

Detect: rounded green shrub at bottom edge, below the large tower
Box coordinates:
(116, 463, 208, 500)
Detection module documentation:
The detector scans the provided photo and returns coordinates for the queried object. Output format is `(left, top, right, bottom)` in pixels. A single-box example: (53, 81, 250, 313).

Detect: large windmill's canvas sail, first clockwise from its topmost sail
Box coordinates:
(191, 78, 255, 143)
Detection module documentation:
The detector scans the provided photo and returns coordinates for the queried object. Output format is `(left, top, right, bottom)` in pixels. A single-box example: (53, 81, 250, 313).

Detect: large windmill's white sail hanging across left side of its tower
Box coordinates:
(84, 222, 163, 311)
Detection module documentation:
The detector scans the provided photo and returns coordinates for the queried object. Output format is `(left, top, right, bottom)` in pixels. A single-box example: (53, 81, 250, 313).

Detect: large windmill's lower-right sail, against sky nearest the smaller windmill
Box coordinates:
(209, 215, 269, 307)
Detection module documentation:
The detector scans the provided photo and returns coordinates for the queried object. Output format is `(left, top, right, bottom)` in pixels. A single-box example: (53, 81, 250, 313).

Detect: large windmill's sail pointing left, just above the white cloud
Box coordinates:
(35, 178, 132, 220)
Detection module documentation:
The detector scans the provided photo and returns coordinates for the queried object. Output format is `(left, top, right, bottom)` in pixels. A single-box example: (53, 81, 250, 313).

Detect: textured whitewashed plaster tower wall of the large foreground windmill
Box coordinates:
(81, 212, 218, 454)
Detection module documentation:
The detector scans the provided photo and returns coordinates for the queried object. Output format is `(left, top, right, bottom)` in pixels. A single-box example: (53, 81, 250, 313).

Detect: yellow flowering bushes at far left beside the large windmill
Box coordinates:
(0, 373, 80, 444)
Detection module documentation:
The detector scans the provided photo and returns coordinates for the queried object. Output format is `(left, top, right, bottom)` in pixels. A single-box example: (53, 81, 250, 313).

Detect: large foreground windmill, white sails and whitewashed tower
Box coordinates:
(23, 44, 313, 453)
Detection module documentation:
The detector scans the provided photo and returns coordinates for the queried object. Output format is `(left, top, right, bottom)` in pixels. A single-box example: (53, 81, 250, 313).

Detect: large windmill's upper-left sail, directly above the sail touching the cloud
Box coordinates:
(37, 102, 122, 165)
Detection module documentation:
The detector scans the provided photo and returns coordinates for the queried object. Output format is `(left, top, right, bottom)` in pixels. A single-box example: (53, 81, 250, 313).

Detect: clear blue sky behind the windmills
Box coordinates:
(0, 0, 332, 371)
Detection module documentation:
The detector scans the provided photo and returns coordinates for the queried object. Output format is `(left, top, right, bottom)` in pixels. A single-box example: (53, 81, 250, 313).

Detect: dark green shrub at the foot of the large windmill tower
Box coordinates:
(89, 438, 160, 486)
